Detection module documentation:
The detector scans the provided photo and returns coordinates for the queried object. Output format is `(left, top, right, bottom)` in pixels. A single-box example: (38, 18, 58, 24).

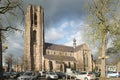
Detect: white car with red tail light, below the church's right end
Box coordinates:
(76, 71, 96, 80)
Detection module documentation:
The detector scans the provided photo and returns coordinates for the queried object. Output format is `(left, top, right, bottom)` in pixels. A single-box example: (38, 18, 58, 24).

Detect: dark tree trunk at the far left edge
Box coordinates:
(0, 30, 3, 80)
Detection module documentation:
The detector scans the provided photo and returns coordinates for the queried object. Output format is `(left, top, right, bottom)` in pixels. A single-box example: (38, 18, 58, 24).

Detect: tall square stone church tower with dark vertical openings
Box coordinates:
(24, 5, 44, 71)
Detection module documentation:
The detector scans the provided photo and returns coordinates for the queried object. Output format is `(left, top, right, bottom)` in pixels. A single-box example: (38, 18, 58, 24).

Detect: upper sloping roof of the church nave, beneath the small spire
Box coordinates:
(45, 43, 86, 52)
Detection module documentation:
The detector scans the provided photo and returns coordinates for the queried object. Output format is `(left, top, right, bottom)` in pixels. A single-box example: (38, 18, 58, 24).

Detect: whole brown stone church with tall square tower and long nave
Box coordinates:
(24, 5, 93, 72)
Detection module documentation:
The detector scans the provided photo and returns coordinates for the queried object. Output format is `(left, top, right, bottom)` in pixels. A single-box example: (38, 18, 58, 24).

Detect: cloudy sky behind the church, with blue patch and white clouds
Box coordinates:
(4, 0, 87, 56)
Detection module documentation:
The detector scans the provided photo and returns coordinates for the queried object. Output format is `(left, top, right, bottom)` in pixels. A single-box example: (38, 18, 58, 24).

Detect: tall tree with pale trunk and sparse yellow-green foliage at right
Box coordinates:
(87, 0, 120, 77)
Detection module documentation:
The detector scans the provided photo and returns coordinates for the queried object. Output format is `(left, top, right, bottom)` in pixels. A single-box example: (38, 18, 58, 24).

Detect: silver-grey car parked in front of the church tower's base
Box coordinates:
(17, 71, 38, 80)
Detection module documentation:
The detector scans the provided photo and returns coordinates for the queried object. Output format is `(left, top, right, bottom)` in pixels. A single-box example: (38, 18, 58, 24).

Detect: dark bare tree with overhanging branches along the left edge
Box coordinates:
(0, 0, 22, 80)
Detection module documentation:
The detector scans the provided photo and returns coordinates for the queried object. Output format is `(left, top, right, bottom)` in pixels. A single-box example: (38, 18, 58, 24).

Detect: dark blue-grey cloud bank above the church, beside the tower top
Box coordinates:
(25, 0, 86, 27)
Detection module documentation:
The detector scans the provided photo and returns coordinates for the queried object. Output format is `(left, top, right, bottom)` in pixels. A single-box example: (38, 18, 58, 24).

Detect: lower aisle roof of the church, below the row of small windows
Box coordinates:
(44, 55, 76, 61)
